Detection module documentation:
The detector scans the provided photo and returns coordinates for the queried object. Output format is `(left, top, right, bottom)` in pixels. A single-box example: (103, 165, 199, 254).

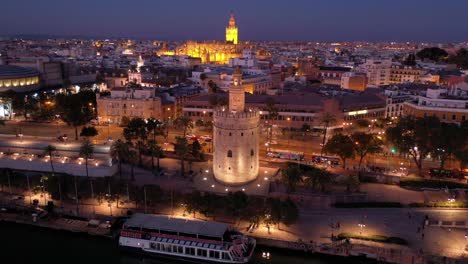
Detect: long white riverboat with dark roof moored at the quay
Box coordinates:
(119, 214, 256, 263)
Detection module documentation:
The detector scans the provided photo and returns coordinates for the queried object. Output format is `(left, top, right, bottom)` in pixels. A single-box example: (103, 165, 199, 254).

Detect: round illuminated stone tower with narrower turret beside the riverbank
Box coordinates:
(213, 68, 260, 185)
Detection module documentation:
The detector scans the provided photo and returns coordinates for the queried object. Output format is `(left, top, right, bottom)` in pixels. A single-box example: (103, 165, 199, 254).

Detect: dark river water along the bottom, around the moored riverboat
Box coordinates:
(0, 221, 372, 264)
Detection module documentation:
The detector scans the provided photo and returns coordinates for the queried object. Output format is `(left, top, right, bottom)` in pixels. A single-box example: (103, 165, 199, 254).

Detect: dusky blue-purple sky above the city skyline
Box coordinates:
(0, 0, 468, 42)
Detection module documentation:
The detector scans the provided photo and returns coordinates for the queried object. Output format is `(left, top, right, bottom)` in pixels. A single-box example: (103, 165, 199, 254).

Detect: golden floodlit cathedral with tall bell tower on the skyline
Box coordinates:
(158, 13, 249, 64)
